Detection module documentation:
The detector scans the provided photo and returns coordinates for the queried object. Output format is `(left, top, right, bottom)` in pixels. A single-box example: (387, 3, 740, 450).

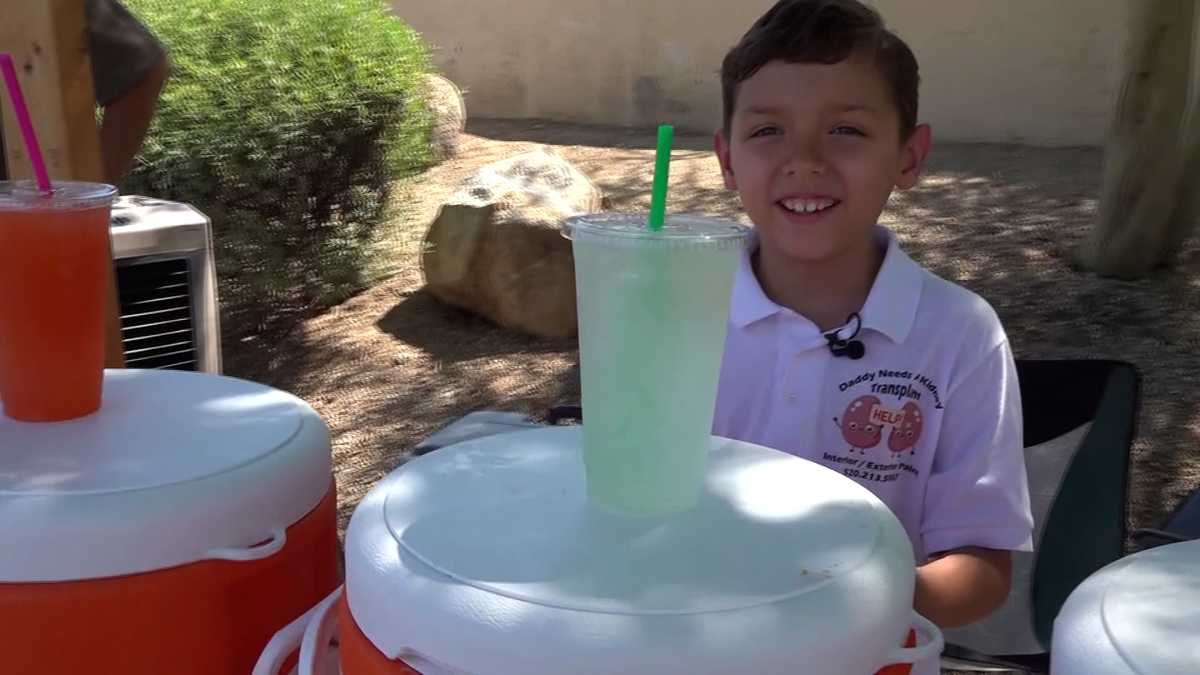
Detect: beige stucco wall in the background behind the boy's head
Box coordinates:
(392, 0, 1139, 145)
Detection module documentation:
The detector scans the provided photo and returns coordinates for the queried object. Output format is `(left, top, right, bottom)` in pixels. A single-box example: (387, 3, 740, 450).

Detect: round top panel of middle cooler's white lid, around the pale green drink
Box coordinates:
(379, 429, 899, 614)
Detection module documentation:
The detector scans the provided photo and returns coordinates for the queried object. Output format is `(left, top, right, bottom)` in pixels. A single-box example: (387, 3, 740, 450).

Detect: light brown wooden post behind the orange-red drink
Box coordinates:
(0, 0, 125, 368)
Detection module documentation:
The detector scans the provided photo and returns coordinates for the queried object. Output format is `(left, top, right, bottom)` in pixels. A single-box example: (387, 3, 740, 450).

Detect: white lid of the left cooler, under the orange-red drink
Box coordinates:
(0, 370, 331, 583)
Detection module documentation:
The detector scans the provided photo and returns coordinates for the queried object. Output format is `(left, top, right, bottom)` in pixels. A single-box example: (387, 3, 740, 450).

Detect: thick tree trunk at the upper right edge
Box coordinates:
(1079, 0, 1200, 279)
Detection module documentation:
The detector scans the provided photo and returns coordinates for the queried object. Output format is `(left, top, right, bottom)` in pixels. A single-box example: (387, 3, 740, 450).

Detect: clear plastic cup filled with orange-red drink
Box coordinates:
(0, 181, 116, 422)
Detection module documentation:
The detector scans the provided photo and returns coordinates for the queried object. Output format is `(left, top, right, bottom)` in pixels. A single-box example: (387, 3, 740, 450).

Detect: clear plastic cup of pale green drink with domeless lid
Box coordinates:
(565, 214, 749, 515)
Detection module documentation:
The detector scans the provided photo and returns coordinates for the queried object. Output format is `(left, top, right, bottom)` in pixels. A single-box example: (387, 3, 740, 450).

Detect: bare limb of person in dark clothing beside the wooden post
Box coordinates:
(100, 59, 168, 185)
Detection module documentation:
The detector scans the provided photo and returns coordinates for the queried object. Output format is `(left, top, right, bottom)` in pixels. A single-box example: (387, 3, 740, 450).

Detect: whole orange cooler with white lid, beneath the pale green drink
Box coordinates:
(253, 428, 942, 675)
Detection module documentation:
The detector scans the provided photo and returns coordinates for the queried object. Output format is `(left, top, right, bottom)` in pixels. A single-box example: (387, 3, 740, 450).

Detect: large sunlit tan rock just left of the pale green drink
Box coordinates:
(422, 150, 601, 338)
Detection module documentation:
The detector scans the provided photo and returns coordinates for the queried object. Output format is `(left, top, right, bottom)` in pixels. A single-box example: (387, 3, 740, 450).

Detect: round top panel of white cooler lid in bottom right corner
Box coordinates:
(1102, 540, 1200, 675)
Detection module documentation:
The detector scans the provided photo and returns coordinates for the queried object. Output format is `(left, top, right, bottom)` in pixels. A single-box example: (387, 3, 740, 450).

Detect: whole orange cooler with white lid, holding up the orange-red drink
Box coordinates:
(0, 370, 340, 675)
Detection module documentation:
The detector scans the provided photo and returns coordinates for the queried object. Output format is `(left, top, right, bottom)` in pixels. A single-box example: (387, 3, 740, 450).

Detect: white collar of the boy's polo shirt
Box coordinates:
(730, 226, 923, 342)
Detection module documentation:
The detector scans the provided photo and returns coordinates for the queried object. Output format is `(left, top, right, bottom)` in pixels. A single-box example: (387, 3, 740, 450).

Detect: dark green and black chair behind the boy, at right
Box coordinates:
(942, 360, 1140, 673)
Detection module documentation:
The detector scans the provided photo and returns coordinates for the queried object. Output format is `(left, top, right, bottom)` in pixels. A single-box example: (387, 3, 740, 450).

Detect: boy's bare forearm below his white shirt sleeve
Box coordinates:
(913, 546, 1013, 628)
